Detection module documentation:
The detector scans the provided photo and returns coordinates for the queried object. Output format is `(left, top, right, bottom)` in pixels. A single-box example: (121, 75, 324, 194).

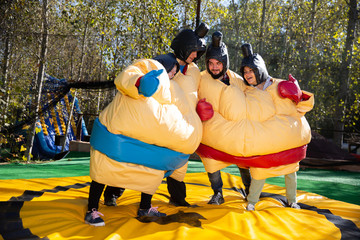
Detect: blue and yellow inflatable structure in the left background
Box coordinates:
(32, 75, 88, 160)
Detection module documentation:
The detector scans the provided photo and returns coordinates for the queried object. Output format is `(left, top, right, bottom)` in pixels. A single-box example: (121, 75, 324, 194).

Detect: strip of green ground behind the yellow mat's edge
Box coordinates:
(0, 156, 360, 205)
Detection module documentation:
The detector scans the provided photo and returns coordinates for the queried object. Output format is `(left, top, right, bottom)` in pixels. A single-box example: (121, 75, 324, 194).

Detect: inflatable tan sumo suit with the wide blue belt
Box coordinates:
(90, 54, 202, 195)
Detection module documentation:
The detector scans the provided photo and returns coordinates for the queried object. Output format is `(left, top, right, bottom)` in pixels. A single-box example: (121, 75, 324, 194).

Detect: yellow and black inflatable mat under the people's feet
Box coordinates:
(0, 173, 360, 240)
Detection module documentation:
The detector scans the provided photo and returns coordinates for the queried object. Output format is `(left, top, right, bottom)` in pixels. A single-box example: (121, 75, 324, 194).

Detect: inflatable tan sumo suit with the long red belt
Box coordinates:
(197, 42, 314, 179)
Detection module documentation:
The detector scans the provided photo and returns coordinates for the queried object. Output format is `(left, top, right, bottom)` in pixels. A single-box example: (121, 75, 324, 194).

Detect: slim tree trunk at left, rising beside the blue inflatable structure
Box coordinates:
(25, 0, 48, 162)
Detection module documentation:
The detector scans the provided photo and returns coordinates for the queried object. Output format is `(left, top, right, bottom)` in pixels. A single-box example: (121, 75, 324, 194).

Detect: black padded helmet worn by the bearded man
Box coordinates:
(205, 31, 229, 79)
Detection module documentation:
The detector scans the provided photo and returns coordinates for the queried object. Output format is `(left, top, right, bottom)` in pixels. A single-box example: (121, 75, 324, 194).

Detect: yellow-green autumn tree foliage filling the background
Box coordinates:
(0, 0, 360, 146)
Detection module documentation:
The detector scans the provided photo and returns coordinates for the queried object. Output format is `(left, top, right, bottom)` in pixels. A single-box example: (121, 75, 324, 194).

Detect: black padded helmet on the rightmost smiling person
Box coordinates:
(240, 43, 269, 85)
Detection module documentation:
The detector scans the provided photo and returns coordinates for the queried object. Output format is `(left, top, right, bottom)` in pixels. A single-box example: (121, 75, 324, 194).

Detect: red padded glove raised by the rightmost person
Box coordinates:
(278, 74, 302, 104)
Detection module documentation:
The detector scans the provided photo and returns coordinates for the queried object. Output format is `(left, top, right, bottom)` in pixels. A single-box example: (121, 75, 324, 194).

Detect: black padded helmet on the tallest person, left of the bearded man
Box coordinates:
(170, 23, 209, 62)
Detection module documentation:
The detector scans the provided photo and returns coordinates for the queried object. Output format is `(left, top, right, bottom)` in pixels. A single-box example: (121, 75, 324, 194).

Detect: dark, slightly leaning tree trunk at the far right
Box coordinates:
(333, 0, 358, 146)
